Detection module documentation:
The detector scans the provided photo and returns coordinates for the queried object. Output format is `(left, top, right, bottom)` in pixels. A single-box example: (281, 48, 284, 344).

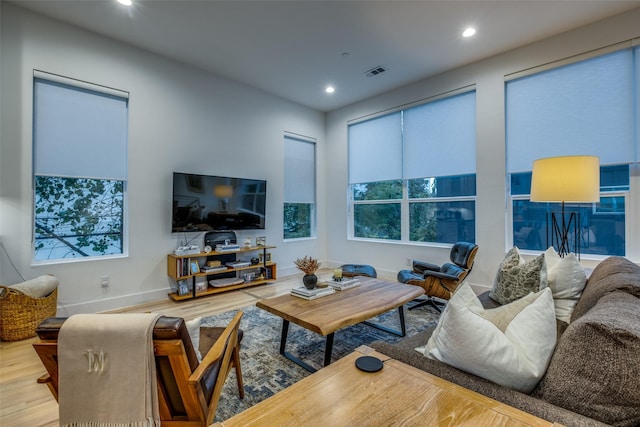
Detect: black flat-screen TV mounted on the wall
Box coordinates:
(171, 172, 267, 233)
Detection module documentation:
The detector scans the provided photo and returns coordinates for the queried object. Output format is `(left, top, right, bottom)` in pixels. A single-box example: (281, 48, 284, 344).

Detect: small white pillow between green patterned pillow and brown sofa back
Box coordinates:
(544, 246, 587, 323)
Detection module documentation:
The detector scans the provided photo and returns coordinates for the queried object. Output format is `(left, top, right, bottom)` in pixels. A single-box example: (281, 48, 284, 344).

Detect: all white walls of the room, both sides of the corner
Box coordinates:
(0, 2, 640, 424)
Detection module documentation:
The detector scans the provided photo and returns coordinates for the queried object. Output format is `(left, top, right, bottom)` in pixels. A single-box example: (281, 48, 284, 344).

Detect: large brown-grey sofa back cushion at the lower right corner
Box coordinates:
(533, 291, 640, 427)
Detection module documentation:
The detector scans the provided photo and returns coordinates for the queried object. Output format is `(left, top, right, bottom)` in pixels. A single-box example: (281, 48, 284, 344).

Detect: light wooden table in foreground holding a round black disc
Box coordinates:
(214, 346, 556, 427)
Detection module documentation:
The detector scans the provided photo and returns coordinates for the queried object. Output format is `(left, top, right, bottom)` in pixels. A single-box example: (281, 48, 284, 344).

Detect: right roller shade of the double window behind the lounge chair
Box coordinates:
(403, 91, 476, 179)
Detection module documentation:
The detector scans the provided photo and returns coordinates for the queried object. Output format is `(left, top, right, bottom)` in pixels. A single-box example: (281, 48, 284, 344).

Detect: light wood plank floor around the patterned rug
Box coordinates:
(0, 270, 394, 427)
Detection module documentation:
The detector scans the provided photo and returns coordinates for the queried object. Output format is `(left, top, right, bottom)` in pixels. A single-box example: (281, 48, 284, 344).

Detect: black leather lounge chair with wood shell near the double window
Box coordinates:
(398, 242, 478, 311)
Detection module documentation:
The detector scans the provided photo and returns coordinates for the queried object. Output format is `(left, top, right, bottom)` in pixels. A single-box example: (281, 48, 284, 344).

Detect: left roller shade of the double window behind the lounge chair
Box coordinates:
(349, 112, 402, 184)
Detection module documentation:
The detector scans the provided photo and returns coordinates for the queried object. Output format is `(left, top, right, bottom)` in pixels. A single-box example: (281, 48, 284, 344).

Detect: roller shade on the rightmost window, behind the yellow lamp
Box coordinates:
(506, 49, 635, 173)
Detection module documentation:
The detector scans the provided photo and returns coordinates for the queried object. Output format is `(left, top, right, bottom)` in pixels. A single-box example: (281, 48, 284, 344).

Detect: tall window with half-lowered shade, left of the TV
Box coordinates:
(33, 72, 128, 261)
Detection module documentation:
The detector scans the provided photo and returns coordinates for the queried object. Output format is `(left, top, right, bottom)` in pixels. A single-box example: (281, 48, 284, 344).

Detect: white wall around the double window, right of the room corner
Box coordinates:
(325, 9, 640, 292)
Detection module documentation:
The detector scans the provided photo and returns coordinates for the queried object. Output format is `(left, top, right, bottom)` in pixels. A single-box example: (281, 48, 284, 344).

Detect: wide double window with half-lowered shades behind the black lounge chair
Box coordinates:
(349, 91, 476, 243)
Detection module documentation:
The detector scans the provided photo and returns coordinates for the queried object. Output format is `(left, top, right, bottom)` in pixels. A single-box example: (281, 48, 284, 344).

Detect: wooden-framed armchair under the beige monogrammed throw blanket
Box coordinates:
(33, 311, 244, 427)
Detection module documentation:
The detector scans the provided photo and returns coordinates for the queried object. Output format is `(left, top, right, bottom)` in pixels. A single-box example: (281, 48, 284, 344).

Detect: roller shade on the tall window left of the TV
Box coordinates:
(33, 78, 127, 180)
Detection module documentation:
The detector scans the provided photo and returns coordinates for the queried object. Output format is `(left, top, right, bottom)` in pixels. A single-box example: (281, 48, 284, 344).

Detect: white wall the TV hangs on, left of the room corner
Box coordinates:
(0, 3, 325, 314)
